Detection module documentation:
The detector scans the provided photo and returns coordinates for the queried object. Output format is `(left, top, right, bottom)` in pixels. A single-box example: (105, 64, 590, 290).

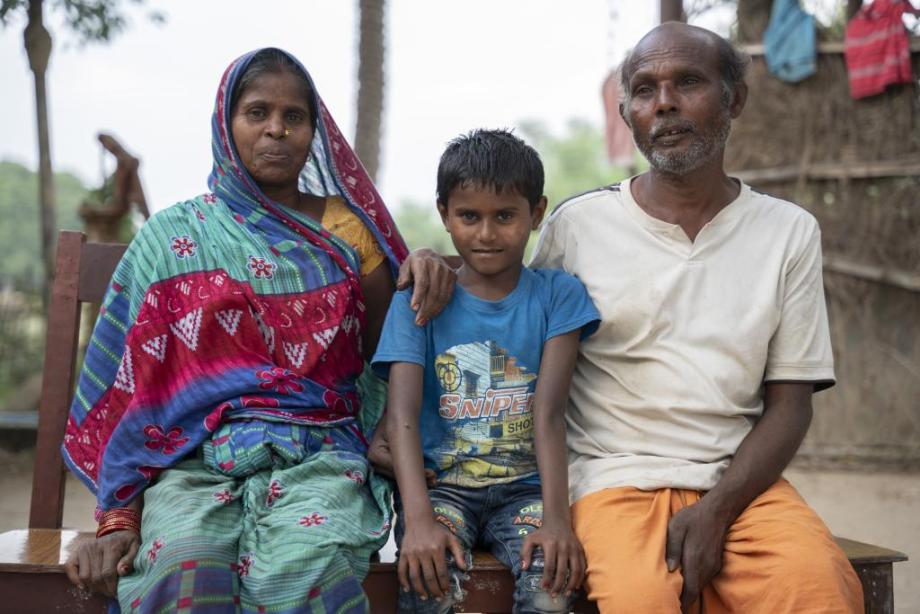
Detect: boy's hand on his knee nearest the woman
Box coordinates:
(397, 520, 466, 600)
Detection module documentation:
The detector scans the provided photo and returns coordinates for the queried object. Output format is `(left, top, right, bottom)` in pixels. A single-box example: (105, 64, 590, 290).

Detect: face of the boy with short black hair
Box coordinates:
(438, 184, 546, 286)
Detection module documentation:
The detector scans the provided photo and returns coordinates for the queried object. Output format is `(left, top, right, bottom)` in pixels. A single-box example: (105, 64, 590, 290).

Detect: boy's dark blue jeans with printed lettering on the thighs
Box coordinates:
(396, 482, 573, 614)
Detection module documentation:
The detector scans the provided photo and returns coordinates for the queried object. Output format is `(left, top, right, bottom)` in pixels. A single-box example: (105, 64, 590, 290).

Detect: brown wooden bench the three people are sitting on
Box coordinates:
(0, 231, 907, 614)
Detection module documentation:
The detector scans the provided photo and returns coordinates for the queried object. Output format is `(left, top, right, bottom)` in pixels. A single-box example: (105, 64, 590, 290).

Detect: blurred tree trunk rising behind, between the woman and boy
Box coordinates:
(355, 0, 386, 181)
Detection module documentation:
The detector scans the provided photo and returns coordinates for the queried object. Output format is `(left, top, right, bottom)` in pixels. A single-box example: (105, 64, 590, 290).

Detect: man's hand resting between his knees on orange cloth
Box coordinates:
(665, 498, 729, 612)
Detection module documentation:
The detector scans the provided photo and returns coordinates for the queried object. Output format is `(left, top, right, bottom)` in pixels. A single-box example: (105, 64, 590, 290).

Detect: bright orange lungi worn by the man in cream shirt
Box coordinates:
(572, 479, 863, 614)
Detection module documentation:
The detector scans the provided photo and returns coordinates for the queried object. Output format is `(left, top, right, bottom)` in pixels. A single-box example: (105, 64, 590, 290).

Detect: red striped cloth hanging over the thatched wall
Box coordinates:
(845, 0, 914, 98)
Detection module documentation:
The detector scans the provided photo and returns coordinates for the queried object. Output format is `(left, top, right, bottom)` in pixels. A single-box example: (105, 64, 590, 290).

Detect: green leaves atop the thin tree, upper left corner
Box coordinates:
(0, 0, 166, 43)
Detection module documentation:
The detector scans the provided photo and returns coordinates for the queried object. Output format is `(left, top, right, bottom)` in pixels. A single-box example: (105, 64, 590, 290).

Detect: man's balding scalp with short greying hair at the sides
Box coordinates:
(620, 21, 751, 106)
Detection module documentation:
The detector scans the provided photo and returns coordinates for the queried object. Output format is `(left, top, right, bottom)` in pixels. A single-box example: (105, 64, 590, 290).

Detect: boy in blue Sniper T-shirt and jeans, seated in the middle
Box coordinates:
(373, 130, 600, 612)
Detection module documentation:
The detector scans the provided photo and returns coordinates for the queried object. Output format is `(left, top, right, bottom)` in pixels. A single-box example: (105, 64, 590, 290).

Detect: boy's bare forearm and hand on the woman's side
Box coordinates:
(387, 362, 466, 599)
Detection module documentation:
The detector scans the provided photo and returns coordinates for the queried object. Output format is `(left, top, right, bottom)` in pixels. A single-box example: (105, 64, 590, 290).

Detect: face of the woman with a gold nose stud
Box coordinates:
(230, 71, 313, 190)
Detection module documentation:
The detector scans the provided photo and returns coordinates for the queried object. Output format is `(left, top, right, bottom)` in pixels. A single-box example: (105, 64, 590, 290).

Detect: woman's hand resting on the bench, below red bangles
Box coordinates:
(64, 531, 141, 597)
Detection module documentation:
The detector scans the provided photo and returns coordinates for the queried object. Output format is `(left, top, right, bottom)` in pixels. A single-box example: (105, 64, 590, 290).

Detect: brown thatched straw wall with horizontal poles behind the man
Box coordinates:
(726, 43, 920, 467)
